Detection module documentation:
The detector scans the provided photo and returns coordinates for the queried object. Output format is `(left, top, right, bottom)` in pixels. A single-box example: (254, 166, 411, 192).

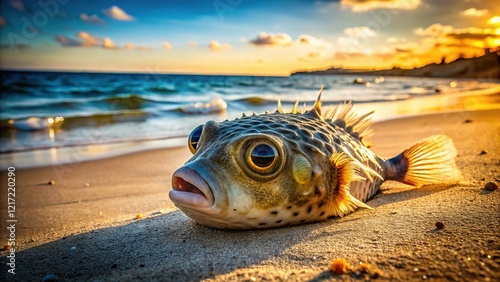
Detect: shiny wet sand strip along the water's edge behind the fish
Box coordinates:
(0, 87, 500, 170)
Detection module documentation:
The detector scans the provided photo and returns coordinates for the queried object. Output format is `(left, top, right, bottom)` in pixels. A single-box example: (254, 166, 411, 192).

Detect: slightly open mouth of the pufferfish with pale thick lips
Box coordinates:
(168, 167, 215, 207)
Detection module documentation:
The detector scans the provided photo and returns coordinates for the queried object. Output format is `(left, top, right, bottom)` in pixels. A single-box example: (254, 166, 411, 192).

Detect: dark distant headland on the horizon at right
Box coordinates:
(291, 48, 500, 79)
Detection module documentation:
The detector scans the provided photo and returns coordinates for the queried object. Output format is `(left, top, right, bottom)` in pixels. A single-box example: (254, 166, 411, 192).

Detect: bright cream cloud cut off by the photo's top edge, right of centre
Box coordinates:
(340, 0, 422, 13)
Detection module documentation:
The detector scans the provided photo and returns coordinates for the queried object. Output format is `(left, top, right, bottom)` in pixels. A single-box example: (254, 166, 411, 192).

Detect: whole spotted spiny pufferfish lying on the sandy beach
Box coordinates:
(169, 92, 461, 229)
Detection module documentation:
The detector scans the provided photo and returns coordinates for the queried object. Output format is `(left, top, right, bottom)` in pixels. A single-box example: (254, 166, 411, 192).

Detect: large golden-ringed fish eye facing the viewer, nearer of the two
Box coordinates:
(245, 142, 279, 174)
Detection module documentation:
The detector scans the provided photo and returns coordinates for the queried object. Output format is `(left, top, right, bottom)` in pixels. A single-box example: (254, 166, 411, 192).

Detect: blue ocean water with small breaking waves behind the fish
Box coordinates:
(0, 71, 498, 154)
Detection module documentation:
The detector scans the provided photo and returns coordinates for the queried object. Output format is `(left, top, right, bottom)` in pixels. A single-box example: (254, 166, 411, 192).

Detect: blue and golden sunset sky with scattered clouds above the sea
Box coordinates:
(0, 0, 500, 75)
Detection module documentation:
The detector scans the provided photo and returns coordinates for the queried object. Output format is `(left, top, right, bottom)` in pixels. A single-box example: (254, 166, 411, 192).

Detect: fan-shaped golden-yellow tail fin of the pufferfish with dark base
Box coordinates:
(385, 135, 462, 187)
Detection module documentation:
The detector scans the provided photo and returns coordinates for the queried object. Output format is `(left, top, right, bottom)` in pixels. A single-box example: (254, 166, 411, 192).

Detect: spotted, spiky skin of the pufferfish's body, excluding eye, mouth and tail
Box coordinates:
(179, 110, 382, 228)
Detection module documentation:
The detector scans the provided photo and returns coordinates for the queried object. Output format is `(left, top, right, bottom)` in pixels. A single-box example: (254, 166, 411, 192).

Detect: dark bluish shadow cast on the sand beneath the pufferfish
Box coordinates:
(7, 184, 454, 281)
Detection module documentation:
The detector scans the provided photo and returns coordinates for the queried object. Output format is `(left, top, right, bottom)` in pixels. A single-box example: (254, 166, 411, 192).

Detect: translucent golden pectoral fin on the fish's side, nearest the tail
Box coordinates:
(330, 152, 371, 217)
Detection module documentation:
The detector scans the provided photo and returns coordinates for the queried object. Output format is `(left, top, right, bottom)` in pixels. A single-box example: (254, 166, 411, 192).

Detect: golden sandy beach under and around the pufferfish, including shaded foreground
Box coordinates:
(0, 107, 500, 281)
